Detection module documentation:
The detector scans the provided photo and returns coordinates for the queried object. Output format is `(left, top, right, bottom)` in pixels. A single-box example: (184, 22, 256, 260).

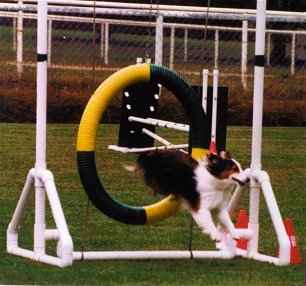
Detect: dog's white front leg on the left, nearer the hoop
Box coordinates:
(193, 208, 222, 241)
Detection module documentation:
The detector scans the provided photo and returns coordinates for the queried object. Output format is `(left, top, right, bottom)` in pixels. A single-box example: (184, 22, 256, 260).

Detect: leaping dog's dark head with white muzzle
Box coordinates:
(206, 151, 248, 185)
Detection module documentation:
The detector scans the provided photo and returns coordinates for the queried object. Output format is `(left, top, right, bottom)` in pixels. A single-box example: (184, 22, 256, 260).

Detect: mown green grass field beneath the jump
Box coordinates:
(0, 123, 306, 286)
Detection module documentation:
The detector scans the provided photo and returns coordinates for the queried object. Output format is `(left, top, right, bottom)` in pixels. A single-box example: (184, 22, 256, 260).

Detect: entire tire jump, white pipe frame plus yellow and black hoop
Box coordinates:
(7, 0, 290, 267)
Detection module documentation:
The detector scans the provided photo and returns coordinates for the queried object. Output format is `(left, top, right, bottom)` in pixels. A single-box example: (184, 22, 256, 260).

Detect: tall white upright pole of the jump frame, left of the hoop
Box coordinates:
(34, 0, 48, 255)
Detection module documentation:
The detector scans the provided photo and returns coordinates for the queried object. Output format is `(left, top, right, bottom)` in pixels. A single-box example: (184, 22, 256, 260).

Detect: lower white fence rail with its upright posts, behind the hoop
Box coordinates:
(0, 8, 306, 87)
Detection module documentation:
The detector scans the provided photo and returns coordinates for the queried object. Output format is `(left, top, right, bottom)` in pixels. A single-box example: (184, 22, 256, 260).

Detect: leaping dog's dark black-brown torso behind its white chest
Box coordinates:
(137, 150, 199, 210)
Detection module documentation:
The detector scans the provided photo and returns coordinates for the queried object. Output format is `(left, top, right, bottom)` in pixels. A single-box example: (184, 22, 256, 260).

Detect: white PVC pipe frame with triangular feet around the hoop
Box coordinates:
(7, 0, 290, 267)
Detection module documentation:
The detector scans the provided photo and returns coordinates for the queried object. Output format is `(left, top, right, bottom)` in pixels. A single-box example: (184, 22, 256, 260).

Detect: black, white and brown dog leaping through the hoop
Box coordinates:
(137, 150, 248, 242)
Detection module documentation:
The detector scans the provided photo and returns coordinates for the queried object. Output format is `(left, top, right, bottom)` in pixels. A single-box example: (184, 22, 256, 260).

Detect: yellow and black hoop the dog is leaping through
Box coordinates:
(77, 64, 208, 225)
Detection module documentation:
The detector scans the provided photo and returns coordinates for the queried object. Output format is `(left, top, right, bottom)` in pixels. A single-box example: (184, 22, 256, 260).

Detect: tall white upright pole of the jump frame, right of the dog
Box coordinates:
(248, 0, 267, 256)
